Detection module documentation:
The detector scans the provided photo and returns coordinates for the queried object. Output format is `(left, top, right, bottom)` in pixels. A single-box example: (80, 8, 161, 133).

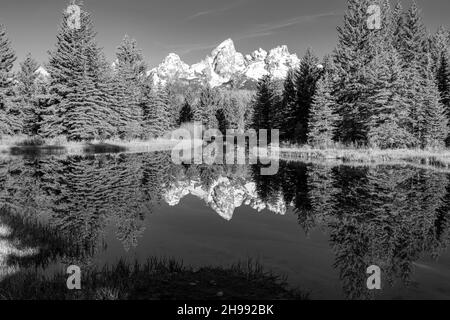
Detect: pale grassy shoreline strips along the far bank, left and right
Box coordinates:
(0, 137, 450, 171)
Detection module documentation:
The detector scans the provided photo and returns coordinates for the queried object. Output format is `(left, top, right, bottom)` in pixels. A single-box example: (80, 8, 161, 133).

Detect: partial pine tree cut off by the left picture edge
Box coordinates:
(0, 25, 22, 135)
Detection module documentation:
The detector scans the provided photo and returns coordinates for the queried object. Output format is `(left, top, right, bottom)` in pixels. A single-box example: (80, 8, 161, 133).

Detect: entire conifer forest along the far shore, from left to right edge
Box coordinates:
(0, 0, 450, 149)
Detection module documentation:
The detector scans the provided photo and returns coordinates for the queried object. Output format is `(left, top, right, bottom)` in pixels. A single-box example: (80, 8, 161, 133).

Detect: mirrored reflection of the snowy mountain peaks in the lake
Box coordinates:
(163, 177, 286, 221)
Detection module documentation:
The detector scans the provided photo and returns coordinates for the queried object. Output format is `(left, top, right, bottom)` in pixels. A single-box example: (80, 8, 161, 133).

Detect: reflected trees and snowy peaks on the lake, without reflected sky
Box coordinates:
(0, 152, 450, 299)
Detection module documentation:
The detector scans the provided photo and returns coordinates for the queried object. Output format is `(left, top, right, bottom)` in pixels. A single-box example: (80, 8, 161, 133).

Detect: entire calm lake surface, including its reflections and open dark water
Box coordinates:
(0, 153, 450, 299)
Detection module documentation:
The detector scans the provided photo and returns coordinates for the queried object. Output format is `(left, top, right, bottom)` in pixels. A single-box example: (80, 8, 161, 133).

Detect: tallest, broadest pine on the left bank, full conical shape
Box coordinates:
(40, 2, 111, 140)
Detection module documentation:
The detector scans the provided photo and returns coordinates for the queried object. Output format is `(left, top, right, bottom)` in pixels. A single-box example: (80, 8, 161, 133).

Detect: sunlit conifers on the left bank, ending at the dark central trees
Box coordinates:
(0, 1, 255, 141)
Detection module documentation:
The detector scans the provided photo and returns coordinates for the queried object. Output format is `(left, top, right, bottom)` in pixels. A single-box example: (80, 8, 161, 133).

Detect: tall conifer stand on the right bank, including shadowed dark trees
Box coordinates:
(253, 0, 450, 148)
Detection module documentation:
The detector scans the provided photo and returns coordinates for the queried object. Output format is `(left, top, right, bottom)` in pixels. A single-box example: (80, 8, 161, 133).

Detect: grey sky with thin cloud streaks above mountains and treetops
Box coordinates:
(0, 0, 450, 67)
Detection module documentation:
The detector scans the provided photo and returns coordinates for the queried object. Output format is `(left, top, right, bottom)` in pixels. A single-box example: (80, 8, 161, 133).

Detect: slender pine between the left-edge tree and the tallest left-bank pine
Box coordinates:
(16, 54, 39, 136)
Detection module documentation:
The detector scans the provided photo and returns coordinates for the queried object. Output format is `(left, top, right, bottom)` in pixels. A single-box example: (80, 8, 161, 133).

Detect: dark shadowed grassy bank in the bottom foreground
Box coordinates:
(0, 258, 308, 300)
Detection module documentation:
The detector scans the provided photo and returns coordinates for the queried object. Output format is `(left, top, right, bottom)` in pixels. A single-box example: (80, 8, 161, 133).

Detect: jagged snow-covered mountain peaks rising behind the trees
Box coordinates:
(149, 39, 300, 88)
